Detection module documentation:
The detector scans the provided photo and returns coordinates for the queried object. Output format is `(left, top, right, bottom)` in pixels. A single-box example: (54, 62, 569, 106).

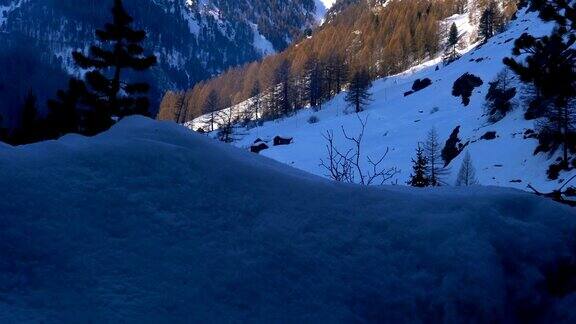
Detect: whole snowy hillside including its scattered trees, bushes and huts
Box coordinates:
(178, 1, 576, 195)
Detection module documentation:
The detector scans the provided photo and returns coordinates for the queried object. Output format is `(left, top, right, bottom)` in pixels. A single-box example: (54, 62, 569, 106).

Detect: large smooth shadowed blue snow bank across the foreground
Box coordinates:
(0, 118, 576, 323)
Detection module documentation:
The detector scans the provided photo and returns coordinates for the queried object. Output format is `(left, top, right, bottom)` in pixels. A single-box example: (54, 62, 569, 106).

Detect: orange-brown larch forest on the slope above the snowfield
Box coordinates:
(158, 0, 517, 123)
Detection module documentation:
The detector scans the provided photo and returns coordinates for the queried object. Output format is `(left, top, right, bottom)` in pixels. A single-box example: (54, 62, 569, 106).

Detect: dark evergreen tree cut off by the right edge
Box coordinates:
(504, 0, 576, 168)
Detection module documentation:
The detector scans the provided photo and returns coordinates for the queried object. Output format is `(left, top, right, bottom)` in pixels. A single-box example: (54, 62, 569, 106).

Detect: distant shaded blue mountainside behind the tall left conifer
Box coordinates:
(0, 0, 316, 123)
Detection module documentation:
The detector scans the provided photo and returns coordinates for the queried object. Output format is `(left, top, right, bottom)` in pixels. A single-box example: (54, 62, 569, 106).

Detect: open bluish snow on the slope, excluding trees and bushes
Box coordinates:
(188, 8, 572, 190)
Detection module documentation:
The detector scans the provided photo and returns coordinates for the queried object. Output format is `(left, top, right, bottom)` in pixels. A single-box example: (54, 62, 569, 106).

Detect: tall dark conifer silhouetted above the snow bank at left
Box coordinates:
(72, 0, 156, 129)
